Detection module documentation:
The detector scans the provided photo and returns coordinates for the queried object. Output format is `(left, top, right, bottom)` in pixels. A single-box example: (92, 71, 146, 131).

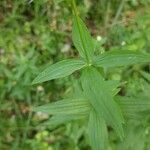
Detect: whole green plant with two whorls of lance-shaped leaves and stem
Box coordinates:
(33, 0, 150, 150)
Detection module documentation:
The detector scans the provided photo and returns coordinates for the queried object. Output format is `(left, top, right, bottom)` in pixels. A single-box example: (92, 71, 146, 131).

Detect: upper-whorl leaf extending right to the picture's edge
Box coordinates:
(94, 50, 150, 67)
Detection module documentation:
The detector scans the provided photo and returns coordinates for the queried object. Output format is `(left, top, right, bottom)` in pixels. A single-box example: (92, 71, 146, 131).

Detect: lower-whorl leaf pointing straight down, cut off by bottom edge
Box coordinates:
(88, 110, 108, 150)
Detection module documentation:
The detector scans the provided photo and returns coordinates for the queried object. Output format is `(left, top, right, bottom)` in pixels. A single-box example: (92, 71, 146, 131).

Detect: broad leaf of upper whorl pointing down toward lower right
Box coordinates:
(82, 67, 124, 138)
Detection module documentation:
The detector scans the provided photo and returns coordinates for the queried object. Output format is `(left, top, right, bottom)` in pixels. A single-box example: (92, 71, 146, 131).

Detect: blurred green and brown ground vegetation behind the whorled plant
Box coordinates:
(0, 0, 150, 150)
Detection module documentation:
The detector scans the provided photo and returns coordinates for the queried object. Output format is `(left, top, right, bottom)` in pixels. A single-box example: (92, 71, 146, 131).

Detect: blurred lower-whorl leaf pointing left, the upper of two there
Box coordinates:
(33, 99, 91, 115)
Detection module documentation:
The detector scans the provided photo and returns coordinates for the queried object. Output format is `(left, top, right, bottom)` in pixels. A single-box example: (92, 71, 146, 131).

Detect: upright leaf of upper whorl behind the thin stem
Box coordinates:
(72, 16, 95, 60)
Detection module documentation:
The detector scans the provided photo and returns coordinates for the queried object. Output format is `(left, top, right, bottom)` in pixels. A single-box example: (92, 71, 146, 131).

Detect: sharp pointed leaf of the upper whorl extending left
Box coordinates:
(32, 59, 85, 84)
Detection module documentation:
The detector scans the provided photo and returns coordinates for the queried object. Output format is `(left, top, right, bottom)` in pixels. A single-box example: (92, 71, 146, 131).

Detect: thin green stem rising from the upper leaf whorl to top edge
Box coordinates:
(72, 0, 90, 64)
